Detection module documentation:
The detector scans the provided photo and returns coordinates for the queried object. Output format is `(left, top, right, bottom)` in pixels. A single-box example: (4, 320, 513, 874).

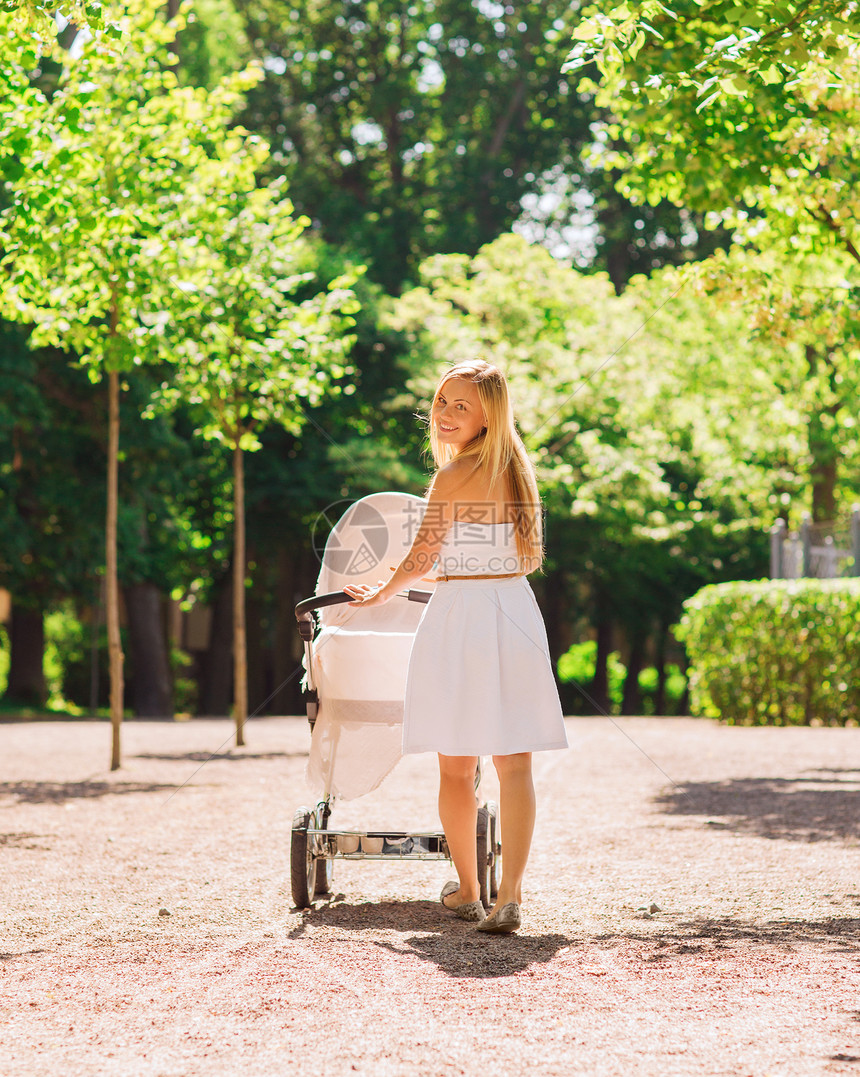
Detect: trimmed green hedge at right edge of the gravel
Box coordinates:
(675, 579, 860, 726)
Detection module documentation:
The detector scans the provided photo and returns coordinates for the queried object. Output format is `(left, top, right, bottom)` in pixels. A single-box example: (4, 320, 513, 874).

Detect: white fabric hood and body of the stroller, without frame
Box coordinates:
(307, 492, 434, 800)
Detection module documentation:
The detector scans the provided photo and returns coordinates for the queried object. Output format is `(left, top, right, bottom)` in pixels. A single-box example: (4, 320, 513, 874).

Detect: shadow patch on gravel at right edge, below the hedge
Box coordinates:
(657, 767, 860, 841)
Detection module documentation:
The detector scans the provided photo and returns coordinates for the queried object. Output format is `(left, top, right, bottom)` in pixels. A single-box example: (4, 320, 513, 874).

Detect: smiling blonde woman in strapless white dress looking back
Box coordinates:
(346, 360, 567, 934)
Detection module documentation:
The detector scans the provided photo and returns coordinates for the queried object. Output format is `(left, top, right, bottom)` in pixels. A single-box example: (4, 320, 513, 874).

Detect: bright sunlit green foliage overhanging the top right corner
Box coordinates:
(567, 0, 860, 262)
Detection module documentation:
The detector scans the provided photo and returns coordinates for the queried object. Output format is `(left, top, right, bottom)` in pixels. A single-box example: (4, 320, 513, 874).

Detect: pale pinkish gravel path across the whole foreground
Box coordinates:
(0, 718, 860, 1077)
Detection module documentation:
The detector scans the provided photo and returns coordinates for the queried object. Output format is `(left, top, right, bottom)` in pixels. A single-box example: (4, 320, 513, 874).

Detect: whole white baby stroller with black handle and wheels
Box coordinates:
(291, 493, 502, 909)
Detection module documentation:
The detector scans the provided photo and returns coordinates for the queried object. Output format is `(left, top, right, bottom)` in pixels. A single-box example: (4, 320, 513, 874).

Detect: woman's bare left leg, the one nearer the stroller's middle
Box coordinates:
(439, 755, 480, 909)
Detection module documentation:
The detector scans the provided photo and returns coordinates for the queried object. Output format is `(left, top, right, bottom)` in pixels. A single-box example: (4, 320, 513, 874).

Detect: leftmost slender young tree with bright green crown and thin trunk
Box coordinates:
(0, 0, 275, 769)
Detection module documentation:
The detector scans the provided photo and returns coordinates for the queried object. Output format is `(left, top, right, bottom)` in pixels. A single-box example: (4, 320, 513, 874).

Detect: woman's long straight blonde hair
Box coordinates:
(428, 359, 544, 572)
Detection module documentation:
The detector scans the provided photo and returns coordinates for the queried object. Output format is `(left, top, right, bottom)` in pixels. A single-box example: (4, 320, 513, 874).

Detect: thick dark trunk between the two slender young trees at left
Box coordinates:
(125, 584, 173, 718)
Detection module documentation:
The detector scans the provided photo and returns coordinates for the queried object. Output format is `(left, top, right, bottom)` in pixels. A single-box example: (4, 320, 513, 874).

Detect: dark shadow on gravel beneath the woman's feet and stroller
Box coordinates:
(291, 897, 570, 979)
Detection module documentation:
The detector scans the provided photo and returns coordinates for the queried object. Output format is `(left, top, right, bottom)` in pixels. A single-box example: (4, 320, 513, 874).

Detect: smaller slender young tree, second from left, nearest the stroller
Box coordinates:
(149, 183, 355, 745)
